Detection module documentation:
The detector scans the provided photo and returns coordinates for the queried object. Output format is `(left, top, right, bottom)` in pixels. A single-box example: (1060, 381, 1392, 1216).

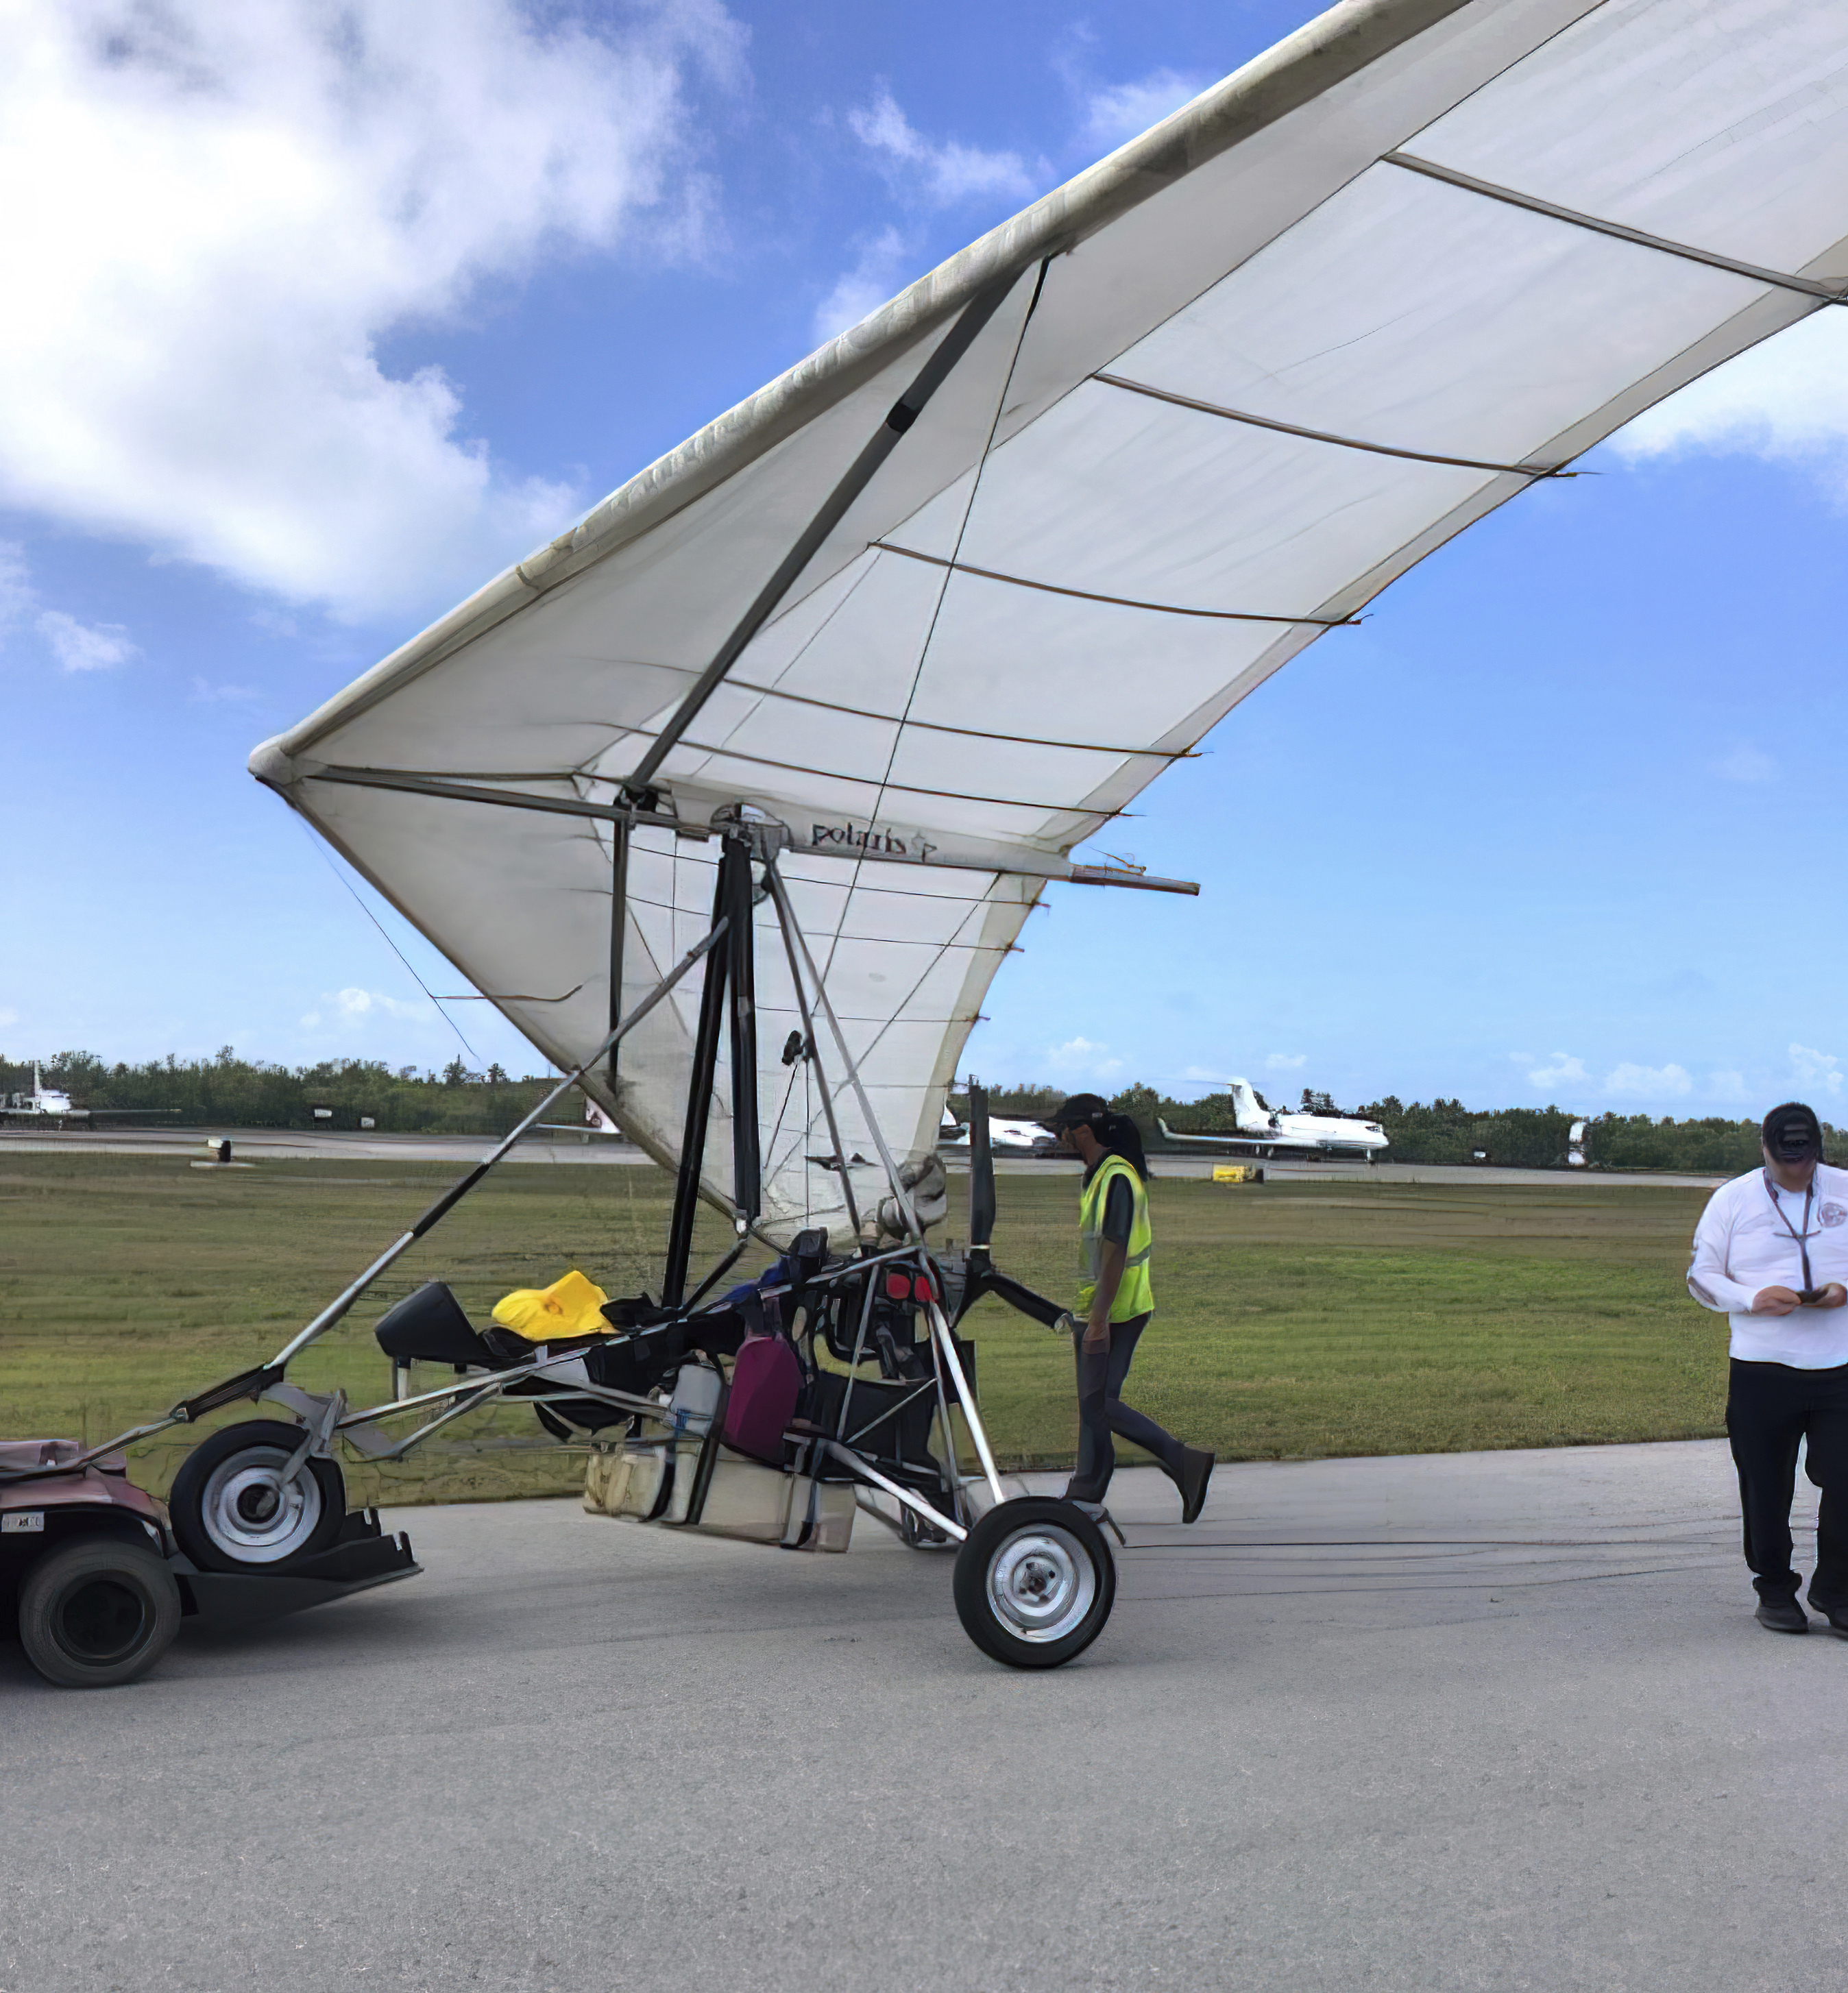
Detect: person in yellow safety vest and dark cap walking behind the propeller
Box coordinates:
(1053, 1094, 1212, 1523)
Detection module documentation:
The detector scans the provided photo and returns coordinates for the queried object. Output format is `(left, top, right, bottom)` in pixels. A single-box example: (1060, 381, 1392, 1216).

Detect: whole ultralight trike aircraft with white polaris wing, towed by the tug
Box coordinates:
(14, 0, 1848, 1666)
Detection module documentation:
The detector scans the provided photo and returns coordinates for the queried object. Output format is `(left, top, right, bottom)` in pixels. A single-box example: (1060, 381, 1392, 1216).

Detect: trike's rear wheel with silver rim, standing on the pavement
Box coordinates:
(953, 1495, 1117, 1668)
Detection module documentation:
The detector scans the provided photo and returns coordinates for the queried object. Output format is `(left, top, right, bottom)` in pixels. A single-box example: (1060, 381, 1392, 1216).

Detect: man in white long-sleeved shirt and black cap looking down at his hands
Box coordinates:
(1688, 1100, 1848, 1638)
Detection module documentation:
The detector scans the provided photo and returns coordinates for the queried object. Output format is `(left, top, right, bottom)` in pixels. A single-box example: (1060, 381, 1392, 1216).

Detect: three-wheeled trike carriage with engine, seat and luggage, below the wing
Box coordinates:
(14, 827, 1115, 1668)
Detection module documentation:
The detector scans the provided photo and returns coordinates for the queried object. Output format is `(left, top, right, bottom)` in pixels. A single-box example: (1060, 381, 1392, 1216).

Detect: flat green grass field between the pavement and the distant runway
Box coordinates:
(0, 1156, 1727, 1501)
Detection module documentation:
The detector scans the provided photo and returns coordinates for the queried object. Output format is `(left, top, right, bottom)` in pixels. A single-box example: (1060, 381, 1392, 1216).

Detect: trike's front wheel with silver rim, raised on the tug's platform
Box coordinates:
(167, 1419, 347, 1572)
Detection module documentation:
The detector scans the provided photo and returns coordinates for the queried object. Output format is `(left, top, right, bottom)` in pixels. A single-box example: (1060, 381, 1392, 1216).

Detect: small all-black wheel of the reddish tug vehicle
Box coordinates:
(20, 1537, 180, 1688)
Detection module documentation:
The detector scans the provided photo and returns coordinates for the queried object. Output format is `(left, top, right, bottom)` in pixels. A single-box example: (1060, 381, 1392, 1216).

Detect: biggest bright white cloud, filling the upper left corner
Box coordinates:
(0, 0, 744, 614)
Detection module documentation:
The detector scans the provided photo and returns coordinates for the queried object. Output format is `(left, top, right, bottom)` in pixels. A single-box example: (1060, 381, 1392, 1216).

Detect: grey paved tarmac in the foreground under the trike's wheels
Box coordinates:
(0, 1441, 1848, 1993)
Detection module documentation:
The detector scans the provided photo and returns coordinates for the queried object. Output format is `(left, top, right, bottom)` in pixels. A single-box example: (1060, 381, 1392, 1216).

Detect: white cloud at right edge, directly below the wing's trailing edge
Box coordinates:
(1613, 311, 1848, 498)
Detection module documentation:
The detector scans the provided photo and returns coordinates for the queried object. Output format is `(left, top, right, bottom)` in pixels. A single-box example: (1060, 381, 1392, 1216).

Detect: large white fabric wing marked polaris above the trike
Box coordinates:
(251, 0, 1848, 1232)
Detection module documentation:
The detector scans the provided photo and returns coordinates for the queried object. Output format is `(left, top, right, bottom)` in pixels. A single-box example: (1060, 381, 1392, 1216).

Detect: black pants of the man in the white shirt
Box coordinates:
(1727, 1357, 1848, 1611)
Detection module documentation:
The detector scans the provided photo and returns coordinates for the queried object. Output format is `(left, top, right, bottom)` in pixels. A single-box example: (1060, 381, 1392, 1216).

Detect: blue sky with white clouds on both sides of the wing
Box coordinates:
(0, 0, 1848, 1118)
